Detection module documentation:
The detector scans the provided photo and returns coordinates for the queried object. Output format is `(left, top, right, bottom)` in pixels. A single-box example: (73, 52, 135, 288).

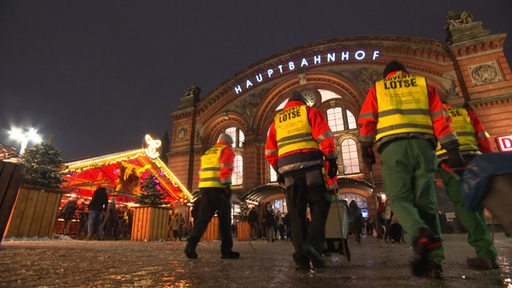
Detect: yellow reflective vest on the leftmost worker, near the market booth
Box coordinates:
(199, 145, 228, 188)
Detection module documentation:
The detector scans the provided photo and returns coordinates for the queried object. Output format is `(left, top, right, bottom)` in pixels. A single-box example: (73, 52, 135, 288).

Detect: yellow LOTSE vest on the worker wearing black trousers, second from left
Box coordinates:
(274, 105, 319, 156)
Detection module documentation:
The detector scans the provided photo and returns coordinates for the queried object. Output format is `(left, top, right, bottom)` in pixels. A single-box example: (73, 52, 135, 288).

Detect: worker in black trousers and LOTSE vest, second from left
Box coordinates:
(265, 91, 338, 269)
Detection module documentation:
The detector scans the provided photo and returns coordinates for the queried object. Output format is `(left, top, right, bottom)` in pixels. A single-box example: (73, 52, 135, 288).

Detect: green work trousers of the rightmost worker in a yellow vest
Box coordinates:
(439, 168, 497, 261)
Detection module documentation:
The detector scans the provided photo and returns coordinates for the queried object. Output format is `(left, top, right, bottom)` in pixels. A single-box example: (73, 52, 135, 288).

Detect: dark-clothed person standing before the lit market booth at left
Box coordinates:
(87, 187, 108, 240)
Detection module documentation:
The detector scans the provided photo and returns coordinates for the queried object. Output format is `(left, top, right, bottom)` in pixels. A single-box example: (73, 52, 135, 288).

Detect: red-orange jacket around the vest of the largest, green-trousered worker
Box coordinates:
(357, 71, 458, 151)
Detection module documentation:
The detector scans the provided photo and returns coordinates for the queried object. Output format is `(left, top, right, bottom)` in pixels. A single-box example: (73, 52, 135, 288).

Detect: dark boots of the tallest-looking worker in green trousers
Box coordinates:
(411, 228, 443, 279)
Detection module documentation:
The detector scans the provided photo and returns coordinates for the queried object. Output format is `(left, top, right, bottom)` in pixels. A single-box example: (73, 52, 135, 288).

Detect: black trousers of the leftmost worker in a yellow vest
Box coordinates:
(187, 188, 233, 253)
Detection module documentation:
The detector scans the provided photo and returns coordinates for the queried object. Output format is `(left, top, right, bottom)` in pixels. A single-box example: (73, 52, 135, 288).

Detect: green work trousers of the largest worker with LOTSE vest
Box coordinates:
(381, 138, 444, 264)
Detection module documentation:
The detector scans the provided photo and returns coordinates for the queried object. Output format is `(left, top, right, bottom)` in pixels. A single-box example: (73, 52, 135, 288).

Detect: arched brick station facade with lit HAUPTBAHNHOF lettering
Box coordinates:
(167, 15, 512, 220)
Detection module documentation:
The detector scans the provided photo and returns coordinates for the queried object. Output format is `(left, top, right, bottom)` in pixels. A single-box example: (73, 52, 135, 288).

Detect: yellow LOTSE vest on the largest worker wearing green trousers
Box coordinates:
(375, 74, 434, 141)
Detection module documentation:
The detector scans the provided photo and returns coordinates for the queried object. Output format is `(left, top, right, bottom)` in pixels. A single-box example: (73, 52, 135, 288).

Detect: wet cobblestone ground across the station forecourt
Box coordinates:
(0, 233, 512, 288)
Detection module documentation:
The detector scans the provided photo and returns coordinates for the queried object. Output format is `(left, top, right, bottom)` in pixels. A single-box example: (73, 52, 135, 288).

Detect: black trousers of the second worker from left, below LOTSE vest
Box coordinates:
(285, 168, 330, 261)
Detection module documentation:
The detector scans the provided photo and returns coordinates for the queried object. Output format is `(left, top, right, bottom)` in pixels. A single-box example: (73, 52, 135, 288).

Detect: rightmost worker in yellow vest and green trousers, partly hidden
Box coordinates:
(436, 103, 499, 270)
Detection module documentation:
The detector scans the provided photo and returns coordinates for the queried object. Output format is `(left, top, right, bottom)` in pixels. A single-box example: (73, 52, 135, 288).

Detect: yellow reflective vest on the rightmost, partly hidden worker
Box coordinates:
(436, 107, 479, 155)
